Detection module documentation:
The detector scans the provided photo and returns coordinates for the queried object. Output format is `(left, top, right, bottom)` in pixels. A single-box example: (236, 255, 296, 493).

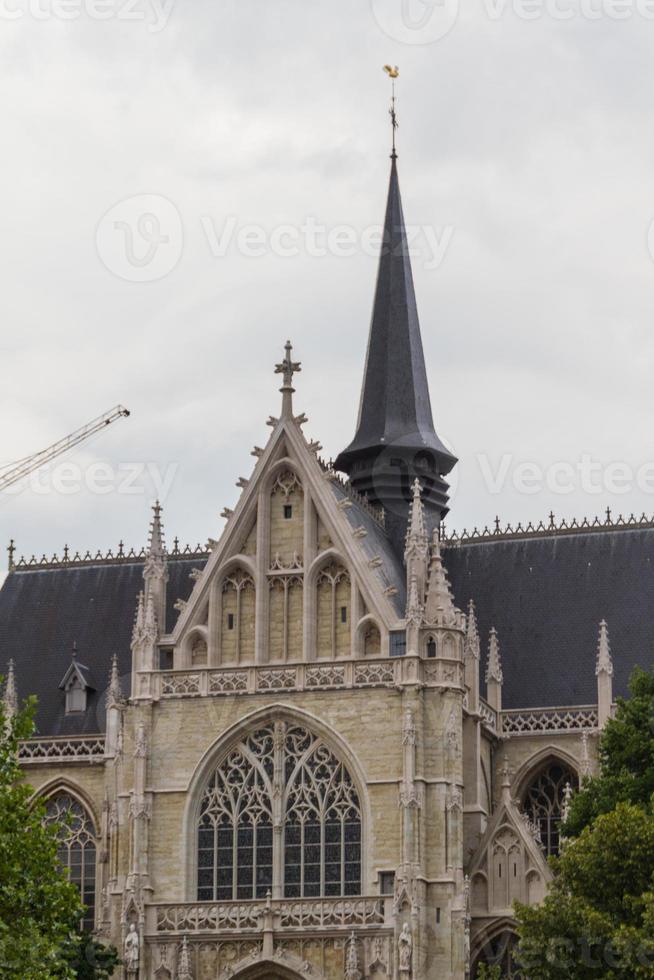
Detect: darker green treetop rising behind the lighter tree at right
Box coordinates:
(565, 667, 654, 838)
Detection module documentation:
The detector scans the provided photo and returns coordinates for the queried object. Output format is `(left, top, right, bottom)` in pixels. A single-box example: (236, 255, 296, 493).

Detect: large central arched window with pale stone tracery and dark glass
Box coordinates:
(197, 721, 361, 901)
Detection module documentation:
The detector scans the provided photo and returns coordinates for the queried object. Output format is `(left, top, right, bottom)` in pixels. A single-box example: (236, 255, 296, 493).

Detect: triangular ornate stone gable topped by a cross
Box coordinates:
(164, 347, 401, 668)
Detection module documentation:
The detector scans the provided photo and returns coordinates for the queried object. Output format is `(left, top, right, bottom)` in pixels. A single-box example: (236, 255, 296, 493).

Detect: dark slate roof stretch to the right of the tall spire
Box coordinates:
(444, 528, 654, 708)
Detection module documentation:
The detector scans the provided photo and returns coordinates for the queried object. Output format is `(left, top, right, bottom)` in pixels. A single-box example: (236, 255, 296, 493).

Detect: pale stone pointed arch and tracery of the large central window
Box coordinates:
(180, 704, 371, 901)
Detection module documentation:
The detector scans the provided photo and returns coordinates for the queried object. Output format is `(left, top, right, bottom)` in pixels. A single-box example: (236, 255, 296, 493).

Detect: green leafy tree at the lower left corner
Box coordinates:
(0, 692, 118, 980)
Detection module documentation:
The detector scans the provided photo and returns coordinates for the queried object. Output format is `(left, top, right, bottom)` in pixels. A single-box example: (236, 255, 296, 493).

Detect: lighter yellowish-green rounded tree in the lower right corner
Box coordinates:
(516, 803, 654, 980)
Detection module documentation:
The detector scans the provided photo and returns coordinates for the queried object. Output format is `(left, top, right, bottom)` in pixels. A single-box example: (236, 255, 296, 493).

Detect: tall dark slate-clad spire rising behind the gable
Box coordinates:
(334, 151, 456, 550)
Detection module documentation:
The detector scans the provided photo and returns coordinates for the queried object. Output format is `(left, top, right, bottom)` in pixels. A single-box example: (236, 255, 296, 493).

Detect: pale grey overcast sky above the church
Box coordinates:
(0, 0, 654, 566)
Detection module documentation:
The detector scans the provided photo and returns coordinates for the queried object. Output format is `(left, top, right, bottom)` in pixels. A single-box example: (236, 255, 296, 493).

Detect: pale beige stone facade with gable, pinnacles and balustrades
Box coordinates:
(3, 364, 611, 980)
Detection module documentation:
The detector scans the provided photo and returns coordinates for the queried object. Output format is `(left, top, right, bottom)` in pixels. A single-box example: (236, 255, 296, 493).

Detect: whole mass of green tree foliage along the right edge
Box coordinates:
(516, 669, 654, 980)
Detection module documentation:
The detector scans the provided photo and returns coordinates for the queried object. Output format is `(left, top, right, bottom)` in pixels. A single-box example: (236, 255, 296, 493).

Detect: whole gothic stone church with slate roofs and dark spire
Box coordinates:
(0, 155, 654, 980)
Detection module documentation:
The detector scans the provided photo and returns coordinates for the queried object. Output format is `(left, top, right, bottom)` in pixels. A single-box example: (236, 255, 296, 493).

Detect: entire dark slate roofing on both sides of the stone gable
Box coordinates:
(5, 520, 654, 735)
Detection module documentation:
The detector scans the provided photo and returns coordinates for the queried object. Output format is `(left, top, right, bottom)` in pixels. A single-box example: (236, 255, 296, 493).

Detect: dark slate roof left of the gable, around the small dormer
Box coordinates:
(0, 558, 204, 735)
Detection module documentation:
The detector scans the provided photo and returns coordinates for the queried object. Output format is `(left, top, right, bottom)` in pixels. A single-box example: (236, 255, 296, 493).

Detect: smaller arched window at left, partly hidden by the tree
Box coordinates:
(45, 792, 96, 929)
